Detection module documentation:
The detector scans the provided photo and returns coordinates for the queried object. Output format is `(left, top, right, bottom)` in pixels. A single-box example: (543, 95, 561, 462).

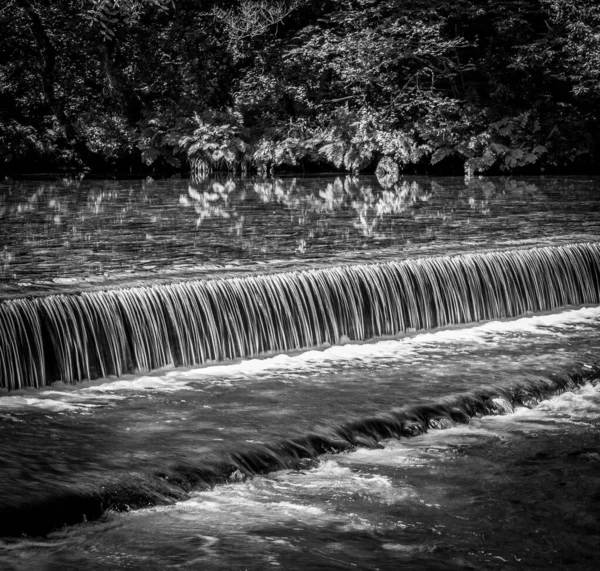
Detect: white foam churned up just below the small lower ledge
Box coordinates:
(126, 383, 600, 529)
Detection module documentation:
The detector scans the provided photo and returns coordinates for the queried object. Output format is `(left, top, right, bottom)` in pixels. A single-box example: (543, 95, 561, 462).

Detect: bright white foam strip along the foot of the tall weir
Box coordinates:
(0, 306, 600, 412)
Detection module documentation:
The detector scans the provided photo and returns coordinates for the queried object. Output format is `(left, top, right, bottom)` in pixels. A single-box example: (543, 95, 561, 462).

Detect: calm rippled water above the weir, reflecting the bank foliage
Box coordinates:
(0, 177, 600, 297)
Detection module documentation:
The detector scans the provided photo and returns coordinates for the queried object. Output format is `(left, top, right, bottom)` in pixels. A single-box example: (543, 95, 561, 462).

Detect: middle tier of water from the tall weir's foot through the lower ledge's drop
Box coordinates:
(0, 307, 600, 536)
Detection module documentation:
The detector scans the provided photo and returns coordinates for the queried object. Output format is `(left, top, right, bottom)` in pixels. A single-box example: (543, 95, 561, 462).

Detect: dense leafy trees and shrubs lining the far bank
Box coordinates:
(0, 0, 600, 175)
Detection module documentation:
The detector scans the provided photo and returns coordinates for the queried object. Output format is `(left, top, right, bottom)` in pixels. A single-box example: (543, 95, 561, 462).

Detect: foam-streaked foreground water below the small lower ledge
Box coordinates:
(0, 370, 600, 570)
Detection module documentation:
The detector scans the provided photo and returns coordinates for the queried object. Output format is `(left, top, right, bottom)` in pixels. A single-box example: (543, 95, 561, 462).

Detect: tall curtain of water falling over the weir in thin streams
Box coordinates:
(0, 243, 600, 390)
